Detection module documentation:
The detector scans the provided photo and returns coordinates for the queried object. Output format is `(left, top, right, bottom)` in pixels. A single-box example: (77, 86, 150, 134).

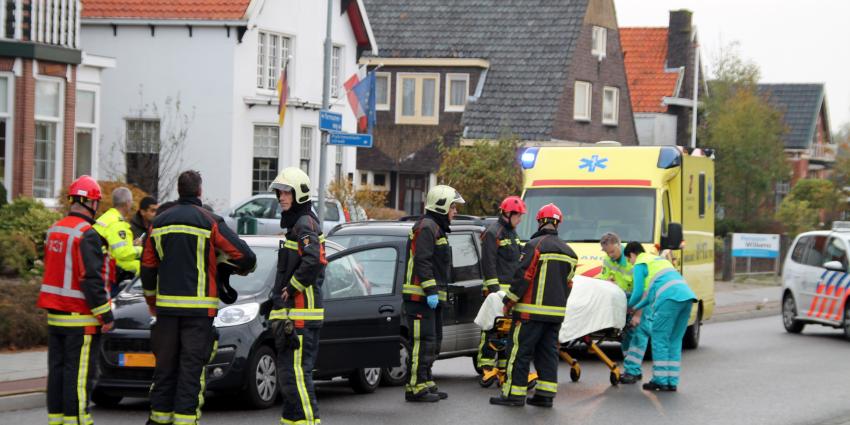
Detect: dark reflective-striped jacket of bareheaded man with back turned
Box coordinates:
(141, 198, 256, 317)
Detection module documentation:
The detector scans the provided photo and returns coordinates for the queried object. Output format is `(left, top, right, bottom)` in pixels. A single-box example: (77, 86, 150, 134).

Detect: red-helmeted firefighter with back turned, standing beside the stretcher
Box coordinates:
(490, 204, 577, 407)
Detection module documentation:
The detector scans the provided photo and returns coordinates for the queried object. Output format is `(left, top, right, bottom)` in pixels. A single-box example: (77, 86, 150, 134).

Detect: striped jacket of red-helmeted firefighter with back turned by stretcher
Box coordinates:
(505, 229, 577, 323)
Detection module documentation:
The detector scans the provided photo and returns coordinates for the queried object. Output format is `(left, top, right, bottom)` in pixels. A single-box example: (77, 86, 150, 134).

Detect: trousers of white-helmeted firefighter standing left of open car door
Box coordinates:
(275, 328, 321, 425)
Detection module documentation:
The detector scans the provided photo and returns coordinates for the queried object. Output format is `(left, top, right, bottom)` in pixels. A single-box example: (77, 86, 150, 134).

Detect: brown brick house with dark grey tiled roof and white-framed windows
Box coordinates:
(357, 0, 637, 214)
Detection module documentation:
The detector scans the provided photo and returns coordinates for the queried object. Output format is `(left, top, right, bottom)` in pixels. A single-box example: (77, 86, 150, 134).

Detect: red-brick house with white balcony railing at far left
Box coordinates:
(0, 0, 115, 206)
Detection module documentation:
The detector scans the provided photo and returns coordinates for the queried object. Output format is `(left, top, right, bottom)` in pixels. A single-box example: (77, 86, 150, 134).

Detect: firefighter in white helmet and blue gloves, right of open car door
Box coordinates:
(402, 185, 466, 403)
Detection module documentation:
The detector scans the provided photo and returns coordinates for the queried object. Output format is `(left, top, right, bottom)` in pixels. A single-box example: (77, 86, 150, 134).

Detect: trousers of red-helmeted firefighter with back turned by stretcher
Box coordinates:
(502, 319, 561, 398)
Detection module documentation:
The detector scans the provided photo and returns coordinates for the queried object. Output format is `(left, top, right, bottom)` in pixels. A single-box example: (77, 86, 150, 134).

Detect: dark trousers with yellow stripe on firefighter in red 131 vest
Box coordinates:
(47, 326, 100, 425)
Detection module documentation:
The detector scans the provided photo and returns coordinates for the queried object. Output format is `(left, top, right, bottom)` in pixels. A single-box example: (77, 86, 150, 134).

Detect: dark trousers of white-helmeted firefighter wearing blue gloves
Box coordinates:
(404, 301, 442, 395)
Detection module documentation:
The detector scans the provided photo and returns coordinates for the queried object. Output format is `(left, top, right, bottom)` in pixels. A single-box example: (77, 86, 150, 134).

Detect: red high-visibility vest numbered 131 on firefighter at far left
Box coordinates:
(38, 216, 110, 327)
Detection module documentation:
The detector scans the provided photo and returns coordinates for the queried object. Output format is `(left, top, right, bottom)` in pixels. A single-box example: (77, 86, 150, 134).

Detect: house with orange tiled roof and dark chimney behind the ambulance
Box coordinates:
(620, 10, 708, 146)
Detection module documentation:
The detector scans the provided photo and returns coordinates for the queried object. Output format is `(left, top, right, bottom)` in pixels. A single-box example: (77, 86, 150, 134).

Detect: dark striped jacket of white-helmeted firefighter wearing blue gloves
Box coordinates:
(402, 213, 452, 303)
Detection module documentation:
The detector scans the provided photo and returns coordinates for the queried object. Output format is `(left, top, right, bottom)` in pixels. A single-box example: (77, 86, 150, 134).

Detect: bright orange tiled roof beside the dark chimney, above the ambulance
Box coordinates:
(620, 28, 679, 112)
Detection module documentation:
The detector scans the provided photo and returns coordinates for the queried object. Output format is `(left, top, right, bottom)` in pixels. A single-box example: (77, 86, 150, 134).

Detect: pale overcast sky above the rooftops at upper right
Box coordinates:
(614, 0, 850, 131)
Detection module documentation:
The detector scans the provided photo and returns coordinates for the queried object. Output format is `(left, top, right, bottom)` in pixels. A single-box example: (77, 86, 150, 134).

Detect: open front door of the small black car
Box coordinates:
(317, 242, 405, 370)
